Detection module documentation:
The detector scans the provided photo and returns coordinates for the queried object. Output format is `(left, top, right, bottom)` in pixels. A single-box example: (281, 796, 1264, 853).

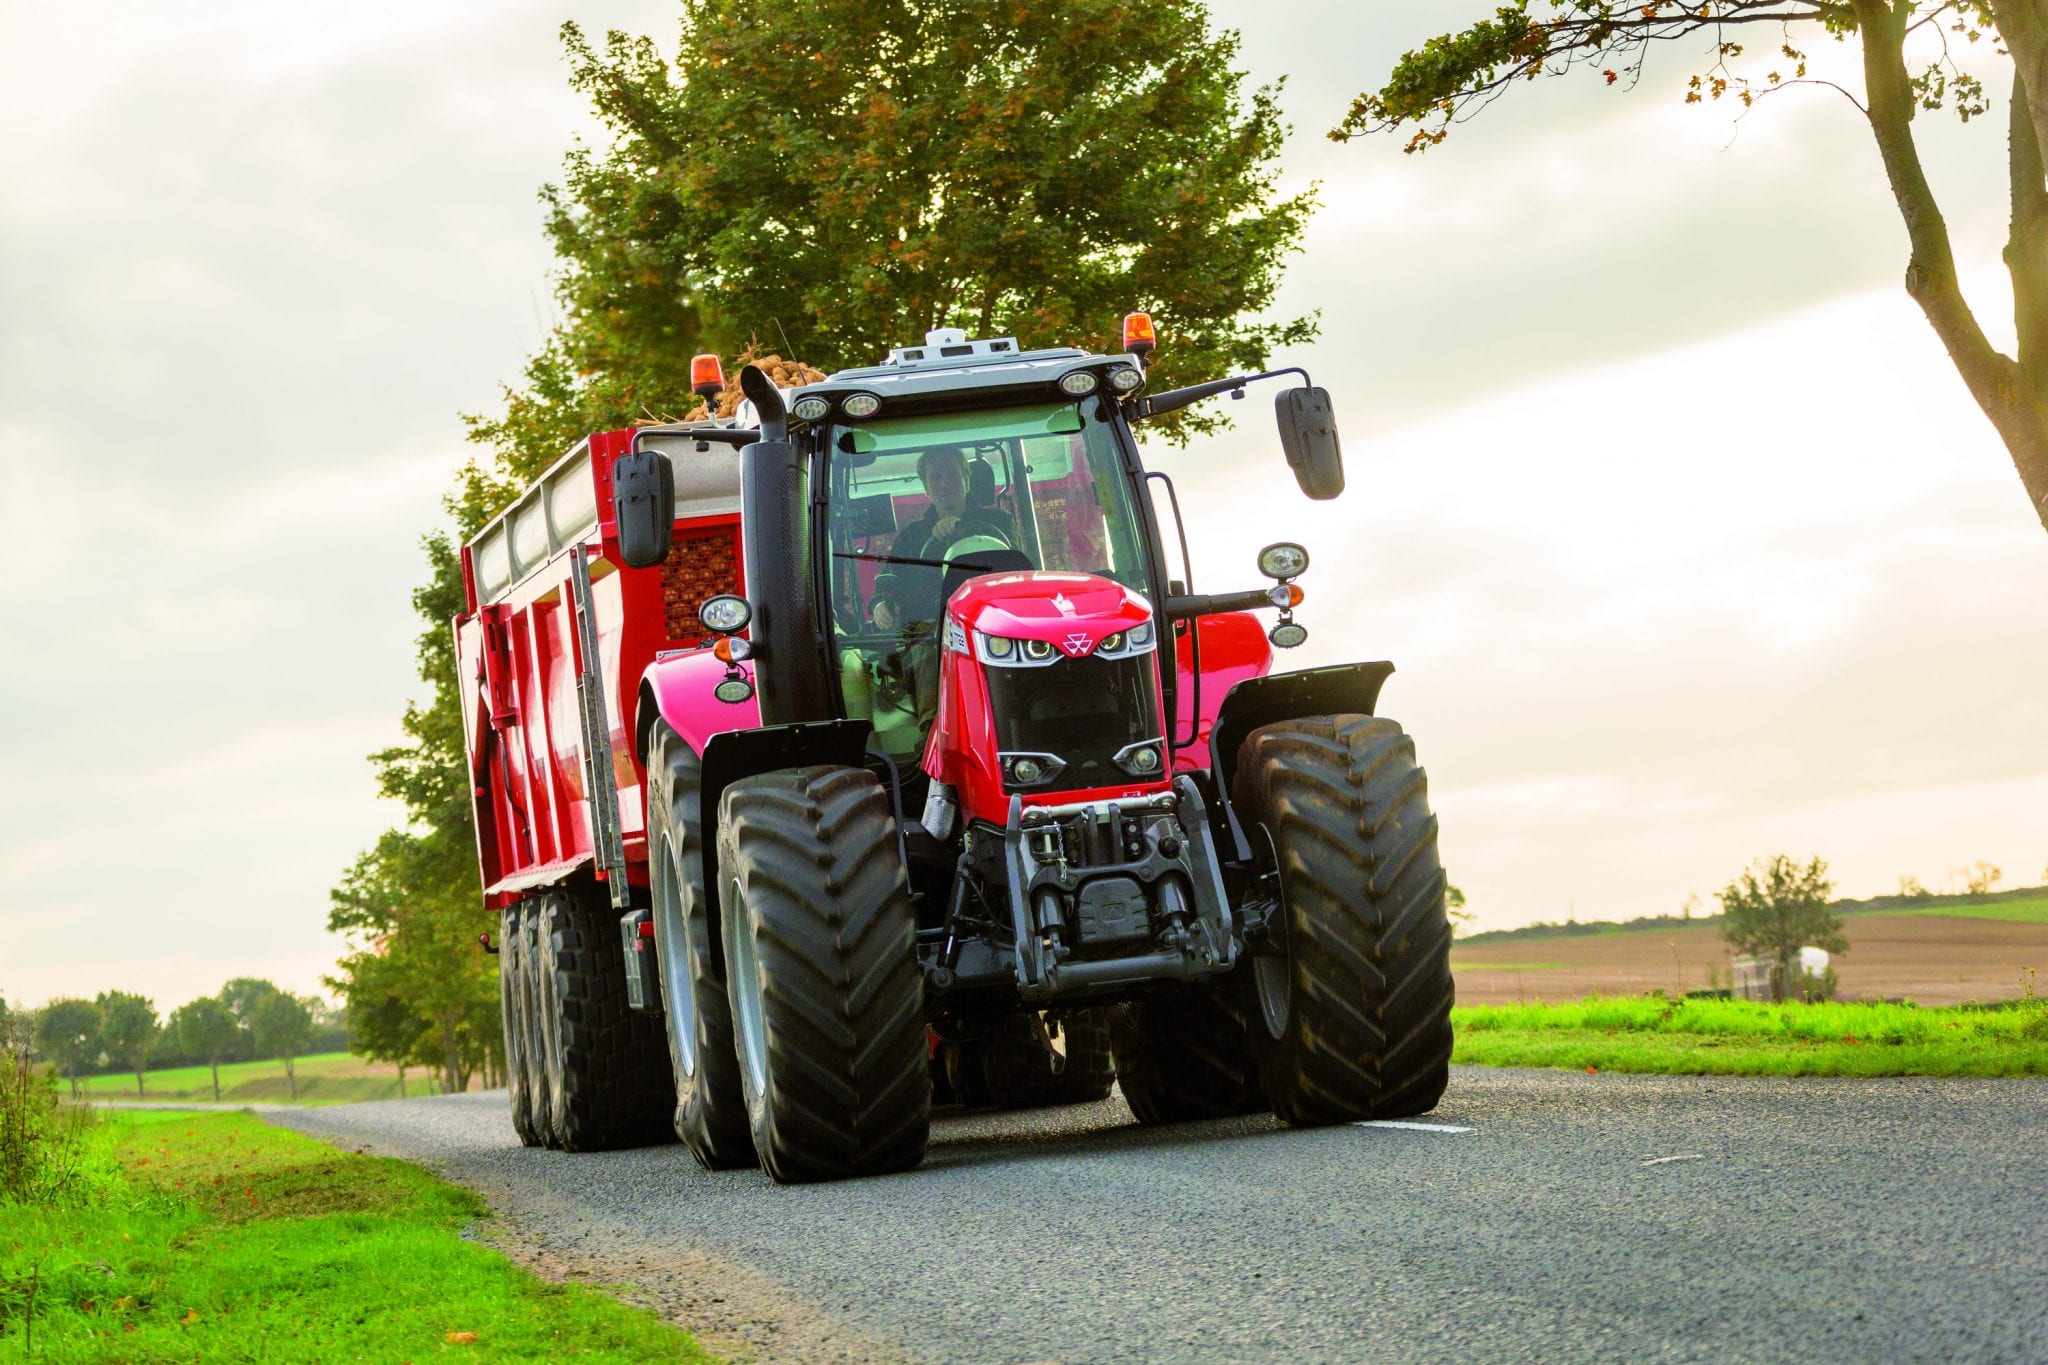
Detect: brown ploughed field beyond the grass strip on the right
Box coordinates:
(1450, 912, 2048, 1005)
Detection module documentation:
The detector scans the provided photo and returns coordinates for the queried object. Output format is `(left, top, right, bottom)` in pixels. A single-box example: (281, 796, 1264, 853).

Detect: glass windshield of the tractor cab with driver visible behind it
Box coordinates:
(829, 401, 1155, 755)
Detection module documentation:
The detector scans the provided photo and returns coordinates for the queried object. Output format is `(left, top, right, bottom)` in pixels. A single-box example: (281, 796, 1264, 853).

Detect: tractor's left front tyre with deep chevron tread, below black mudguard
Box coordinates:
(719, 767, 932, 1183)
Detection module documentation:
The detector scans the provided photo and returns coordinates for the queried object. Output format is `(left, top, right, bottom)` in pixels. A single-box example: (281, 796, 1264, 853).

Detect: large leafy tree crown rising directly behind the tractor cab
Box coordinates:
(475, 0, 1315, 477)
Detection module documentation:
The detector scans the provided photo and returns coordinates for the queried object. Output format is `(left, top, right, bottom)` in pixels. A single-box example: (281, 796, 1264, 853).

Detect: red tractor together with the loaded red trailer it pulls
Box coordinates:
(457, 315, 1452, 1181)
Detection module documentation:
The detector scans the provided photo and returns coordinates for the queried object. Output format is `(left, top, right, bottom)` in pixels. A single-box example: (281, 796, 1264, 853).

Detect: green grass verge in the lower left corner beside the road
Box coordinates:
(0, 1113, 709, 1361)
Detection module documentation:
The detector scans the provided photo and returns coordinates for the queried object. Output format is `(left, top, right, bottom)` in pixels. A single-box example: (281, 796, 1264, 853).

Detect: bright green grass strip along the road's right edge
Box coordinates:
(1452, 997, 2048, 1076)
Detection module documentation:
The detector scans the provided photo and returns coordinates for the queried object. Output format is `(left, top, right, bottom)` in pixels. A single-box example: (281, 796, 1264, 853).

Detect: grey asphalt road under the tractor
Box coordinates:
(268, 1068, 2048, 1363)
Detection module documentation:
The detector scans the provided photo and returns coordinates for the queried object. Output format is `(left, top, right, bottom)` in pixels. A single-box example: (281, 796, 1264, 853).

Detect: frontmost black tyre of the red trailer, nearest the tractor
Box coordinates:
(532, 892, 676, 1152)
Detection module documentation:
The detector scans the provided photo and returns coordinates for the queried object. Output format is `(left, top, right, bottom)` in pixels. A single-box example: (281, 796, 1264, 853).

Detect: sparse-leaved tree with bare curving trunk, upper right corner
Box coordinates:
(1331, 0, 2048, 528)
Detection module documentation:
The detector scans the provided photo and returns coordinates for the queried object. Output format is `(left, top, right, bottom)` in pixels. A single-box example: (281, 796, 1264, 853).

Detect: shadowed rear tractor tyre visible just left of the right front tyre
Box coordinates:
(1110, 982, 1266, 1124)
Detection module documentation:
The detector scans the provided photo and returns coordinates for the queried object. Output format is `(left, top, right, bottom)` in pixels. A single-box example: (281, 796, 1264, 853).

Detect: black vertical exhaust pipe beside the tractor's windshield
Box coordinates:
(739, 364, 834, 724)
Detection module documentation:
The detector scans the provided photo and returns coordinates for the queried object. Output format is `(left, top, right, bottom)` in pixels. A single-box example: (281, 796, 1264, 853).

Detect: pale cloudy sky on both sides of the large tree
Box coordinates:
(0, 0, 2048, 1009)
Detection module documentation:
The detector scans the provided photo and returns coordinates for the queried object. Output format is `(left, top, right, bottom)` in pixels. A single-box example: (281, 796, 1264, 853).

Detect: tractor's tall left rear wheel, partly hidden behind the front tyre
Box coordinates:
(647, 720, 756, 1171)
